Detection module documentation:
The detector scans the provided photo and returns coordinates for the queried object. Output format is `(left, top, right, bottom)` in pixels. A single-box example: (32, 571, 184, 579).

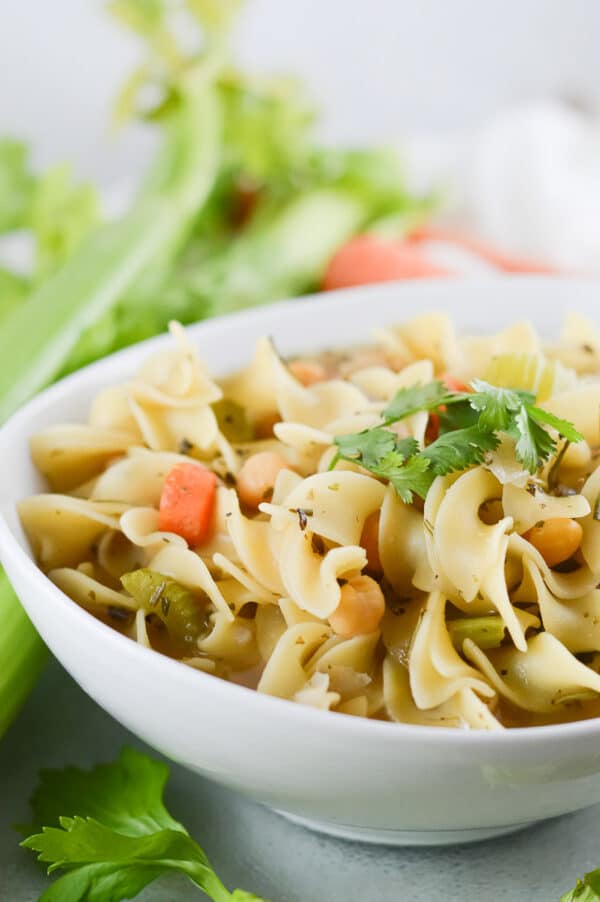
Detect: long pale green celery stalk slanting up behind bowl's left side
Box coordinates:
(0, 87, 220, 422)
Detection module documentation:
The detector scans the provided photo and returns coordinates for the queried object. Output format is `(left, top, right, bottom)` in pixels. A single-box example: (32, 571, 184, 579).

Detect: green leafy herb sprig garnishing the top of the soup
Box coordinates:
(330, 379, 583, 504)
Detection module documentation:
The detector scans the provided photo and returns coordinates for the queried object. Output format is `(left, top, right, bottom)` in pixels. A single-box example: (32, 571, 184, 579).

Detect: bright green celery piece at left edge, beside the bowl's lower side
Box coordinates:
(0, 570, 48, 736)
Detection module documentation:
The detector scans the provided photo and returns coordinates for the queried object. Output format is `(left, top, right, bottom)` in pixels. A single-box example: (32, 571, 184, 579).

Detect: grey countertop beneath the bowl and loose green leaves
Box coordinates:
(0, 662, 600, 902)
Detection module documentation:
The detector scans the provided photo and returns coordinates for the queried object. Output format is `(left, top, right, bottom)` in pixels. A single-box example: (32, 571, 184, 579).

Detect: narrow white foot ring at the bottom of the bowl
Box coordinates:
(274, 808, 533, 846)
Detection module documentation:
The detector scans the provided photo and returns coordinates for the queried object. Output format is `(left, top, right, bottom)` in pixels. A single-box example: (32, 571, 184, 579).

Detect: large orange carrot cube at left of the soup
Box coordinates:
(158, 463, 217, 546)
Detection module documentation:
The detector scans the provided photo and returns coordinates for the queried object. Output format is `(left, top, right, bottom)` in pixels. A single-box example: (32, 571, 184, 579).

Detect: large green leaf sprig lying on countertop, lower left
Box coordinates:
(22, 748, 266, 902)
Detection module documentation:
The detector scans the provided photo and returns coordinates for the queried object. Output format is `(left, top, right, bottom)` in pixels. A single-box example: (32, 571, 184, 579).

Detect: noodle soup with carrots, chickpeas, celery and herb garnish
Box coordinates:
(19, 314, 600, 730)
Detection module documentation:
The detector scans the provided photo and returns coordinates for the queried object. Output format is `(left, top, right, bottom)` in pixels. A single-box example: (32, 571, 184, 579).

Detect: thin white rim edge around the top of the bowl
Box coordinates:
(0, 276, 600, 749)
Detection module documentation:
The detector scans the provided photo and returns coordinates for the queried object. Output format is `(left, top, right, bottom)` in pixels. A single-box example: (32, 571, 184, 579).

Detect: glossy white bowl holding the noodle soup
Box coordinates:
(0, 278, 600, 844)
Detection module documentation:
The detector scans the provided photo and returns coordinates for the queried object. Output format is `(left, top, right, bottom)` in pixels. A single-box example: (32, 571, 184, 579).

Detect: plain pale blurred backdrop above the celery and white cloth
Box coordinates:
(0, 0, 600, 183)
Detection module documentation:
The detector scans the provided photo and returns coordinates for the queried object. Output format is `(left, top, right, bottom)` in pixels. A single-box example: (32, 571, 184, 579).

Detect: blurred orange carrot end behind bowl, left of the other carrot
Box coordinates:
(323, 235, 452, 291)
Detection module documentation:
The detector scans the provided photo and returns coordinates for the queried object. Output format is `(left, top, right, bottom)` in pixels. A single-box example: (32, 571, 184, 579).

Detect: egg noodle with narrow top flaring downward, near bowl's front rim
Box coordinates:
(408, 592, 494, 709)
